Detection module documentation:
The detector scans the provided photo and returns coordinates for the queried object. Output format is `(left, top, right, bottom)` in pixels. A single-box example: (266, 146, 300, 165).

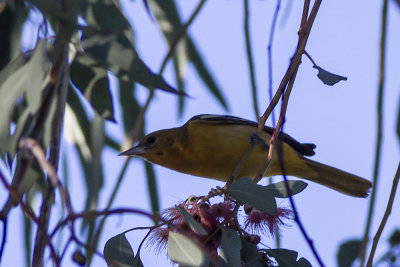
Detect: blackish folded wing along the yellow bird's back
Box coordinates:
(187, 114, 316, 156)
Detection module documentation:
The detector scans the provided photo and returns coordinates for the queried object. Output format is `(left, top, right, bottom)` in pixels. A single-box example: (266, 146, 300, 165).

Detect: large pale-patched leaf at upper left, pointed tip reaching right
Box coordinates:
(82, 28, 180, 94)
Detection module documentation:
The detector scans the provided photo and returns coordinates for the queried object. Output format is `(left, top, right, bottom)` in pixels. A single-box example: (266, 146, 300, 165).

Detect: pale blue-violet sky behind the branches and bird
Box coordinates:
(0, 0, 400, 266)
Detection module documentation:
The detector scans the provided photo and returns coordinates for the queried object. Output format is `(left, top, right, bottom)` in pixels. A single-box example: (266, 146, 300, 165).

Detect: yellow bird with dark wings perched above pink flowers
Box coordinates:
(120, 115, 372, 197)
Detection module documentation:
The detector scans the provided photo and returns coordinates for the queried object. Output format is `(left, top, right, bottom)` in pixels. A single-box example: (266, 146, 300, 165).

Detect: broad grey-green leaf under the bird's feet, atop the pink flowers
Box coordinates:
(227, 177, 276, 215)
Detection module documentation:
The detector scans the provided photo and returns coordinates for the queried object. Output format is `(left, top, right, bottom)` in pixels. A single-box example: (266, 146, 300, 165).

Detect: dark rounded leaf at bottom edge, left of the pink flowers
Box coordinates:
(103, 234, 138, 267)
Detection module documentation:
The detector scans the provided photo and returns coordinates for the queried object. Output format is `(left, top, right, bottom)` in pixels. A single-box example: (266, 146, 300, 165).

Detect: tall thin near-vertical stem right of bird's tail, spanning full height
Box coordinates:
(360, 0, 388, 267)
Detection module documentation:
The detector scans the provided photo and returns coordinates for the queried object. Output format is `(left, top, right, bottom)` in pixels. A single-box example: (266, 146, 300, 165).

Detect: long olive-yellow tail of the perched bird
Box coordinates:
(299, 158, 372, 197)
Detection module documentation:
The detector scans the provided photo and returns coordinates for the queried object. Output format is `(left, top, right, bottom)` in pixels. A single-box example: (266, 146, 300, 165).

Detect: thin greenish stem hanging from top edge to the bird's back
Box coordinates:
(244, 0, 260, 119)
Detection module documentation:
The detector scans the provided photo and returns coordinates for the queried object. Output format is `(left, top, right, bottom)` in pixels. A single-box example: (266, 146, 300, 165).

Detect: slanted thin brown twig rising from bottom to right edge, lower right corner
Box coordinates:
(367, 163, 400, 267)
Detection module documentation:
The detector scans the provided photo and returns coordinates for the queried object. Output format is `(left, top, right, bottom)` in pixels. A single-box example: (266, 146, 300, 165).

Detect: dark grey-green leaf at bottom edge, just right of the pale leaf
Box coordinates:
(220, 228, 242, 267)
